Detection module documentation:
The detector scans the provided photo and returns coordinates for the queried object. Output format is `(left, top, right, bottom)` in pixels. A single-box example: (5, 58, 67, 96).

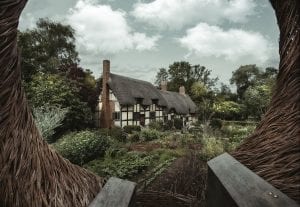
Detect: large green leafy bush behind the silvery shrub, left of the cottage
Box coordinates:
(25, 73, 93, 130)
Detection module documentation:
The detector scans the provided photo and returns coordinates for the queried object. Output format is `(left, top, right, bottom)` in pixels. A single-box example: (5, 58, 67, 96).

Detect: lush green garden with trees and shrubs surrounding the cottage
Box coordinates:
(18, 19, 277, 206)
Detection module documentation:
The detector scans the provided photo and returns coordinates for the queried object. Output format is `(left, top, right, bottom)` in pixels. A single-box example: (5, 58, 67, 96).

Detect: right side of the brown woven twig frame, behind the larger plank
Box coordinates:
(233, 0, 300, 203)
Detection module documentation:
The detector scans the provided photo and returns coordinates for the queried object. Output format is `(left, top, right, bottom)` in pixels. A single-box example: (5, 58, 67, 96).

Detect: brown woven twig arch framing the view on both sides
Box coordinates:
(0, 0, 300, 207)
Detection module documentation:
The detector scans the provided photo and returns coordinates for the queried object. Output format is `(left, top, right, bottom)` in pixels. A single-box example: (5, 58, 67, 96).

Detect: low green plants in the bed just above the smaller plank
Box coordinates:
(84, 152, 153, 179)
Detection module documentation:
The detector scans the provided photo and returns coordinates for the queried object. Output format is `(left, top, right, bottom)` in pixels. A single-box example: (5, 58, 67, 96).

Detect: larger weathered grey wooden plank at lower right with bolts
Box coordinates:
(207, 153, 299, 207)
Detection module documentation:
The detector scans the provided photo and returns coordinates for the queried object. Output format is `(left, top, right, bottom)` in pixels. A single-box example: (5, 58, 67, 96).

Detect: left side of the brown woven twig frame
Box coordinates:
(0, 0, 103, 207)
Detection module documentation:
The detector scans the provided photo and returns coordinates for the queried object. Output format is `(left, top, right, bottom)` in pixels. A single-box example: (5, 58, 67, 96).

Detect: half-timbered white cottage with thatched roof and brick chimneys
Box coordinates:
(96, 60, 196, 128)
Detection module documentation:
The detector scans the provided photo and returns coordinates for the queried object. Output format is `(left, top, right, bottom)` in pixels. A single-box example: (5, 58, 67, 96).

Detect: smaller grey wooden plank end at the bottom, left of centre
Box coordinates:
(89, 177, 136, 207)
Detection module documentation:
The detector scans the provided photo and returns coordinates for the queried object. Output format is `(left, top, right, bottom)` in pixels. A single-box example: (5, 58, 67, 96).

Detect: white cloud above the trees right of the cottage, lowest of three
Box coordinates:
(178, 23, 276, 64)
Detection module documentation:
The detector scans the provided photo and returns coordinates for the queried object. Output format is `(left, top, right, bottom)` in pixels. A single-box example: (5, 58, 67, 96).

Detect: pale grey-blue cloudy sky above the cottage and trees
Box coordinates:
(19, 0, 279, 84)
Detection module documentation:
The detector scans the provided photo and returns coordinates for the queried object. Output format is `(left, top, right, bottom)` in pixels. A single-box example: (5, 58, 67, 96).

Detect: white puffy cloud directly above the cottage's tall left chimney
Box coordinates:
(66, 0, 160, 54)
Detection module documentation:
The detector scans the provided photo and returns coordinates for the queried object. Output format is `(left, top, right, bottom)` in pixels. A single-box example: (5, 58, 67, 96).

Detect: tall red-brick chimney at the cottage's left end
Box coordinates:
(100, 60, 112, 128)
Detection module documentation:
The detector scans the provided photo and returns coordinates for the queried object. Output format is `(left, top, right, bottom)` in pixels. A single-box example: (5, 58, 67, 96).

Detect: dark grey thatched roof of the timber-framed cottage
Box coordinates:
(108, 73, 196, 114)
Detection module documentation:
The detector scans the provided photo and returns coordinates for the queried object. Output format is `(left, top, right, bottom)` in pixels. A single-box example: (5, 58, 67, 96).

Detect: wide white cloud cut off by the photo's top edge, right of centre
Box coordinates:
(131, 0, 256, 29)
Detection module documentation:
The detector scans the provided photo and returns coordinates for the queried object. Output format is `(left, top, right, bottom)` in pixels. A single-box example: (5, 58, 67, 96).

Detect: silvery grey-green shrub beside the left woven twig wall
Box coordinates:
(33, 106, 68, 143)
